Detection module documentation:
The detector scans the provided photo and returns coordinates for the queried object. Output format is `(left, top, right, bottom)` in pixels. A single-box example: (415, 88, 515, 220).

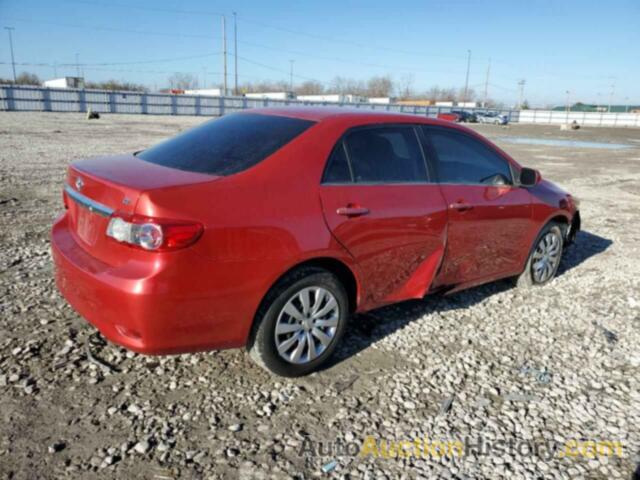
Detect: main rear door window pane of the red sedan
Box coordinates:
(345, 126, 428, 183)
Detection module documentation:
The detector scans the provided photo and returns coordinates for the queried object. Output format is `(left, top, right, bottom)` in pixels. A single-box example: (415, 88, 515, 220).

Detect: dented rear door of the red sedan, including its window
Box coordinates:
(320, 125, 446, 306)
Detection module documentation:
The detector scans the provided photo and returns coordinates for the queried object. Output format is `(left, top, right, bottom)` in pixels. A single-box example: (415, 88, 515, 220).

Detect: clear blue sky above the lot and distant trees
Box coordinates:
(0, 0, 640, 107)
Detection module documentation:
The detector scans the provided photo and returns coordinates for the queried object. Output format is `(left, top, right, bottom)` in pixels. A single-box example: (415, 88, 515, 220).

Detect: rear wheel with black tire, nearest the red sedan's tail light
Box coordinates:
(248, 267, 349, 377)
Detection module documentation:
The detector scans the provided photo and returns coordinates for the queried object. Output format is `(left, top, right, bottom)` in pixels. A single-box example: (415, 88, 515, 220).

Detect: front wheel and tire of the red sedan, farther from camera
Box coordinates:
(516, 222, 564, 288)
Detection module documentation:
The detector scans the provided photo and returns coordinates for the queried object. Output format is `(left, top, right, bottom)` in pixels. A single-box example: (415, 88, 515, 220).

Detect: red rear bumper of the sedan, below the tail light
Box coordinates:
(51, 215, 253, 354)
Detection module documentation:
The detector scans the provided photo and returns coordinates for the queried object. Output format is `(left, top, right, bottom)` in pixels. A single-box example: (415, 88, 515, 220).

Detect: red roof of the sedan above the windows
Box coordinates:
(243, 107, 452, 126)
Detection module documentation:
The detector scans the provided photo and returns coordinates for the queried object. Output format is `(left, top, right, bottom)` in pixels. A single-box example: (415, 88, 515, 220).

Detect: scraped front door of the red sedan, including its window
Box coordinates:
(424, 126, 534, 285)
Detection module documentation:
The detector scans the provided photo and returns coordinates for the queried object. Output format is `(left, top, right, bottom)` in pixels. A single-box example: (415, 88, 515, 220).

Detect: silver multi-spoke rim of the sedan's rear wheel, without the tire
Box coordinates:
(275, 287, 340, 364)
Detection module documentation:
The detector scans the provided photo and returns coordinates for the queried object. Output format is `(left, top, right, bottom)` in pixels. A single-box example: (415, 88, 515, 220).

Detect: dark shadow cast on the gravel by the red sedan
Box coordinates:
(322, 231, 612, 374)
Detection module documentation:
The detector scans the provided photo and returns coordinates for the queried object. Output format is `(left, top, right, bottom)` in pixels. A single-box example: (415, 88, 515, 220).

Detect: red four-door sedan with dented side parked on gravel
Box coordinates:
(51, 108, 580, 376)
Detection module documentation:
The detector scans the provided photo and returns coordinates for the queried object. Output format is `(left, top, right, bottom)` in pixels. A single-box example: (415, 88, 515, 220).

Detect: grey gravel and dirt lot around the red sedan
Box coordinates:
(0, 112, 640, 479)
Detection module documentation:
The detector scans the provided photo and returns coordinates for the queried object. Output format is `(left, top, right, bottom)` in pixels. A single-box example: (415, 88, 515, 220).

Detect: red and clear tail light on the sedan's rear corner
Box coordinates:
(107, 213, 203, 252)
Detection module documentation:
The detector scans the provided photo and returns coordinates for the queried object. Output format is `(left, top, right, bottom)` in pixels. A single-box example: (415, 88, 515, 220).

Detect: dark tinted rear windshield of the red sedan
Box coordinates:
(137, 113, 314, 175)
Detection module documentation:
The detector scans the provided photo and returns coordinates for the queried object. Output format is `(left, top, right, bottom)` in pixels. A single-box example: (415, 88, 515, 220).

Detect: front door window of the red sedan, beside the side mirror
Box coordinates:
(425, 127, 513, 185)
